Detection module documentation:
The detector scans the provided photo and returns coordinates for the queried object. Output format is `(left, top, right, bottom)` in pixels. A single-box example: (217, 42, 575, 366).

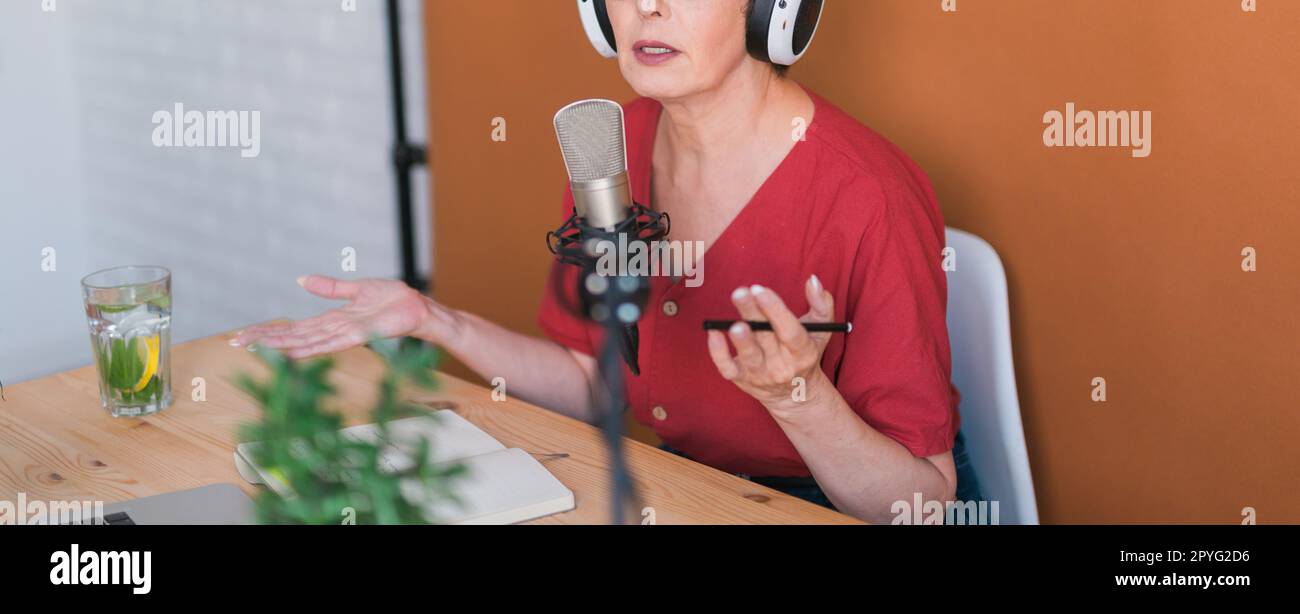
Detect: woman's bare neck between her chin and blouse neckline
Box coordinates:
(657, 65, 813, 172)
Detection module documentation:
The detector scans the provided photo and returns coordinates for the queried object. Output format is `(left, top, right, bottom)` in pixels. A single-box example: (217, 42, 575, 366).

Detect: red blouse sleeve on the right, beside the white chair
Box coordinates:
(836, 176, 959, 457)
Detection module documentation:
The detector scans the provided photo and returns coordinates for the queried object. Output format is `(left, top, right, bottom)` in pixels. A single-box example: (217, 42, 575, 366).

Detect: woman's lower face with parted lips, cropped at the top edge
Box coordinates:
(606, 0, 758, 100)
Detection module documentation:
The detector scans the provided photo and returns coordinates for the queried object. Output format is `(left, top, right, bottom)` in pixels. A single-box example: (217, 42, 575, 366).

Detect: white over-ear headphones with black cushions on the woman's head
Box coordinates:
(577, 0, 824, 66)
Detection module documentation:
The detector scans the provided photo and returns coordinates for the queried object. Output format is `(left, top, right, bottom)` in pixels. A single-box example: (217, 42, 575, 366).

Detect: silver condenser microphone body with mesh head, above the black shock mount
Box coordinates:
(555, 99, 633, 232)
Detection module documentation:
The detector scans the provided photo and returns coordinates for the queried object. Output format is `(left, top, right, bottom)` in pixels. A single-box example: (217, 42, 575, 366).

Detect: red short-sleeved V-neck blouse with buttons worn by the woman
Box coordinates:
(538, 92, 959, 476)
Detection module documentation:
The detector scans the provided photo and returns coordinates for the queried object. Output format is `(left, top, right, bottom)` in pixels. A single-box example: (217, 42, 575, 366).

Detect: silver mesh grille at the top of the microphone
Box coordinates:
(555, 100, 628, 181)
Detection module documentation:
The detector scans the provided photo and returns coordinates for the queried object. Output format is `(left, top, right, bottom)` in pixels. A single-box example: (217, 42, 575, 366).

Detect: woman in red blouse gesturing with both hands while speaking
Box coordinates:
(233, 0, 967, 523)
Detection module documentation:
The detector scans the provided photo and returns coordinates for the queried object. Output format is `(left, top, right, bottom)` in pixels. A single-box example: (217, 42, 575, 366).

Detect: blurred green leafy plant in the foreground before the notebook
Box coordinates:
(237, 338, 464, 524)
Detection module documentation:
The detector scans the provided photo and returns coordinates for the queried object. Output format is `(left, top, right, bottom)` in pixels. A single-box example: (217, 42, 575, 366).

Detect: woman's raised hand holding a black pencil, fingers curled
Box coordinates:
(709, 274, 835, 411)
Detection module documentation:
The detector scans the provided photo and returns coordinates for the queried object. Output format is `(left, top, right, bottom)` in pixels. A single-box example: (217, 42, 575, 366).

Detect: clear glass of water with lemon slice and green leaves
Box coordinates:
(82, 267, 172, 418)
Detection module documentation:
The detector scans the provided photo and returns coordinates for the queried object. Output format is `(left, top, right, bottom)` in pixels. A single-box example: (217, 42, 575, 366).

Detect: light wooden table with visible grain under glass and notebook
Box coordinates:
(0, 329, 857, 524)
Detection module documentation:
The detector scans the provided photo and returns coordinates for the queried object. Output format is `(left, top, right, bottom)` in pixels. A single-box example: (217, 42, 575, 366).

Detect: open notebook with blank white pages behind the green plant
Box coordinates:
(234, 410, 573, 524)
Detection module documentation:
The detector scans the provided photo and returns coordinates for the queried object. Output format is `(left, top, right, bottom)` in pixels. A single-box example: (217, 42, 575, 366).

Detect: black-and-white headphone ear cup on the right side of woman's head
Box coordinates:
(745, 0, 826, 66)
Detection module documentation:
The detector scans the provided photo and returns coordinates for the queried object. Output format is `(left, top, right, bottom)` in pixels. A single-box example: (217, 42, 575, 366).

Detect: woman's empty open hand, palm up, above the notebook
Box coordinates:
(230, 274, 436, 358)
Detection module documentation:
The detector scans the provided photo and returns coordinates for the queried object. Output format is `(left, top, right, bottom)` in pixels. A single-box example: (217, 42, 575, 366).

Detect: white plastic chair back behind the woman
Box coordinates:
(945, 228, 1039, 524)
